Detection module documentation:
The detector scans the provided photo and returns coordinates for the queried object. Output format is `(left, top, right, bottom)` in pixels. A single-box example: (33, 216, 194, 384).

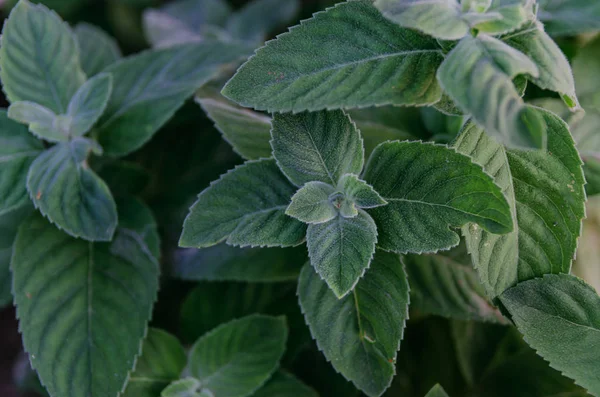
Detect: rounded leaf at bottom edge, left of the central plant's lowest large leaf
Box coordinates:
(189, 315, 287, 397)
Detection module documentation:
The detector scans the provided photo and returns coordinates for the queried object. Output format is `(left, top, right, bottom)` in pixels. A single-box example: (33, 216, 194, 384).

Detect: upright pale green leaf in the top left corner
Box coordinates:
(0, 0, 85, 114)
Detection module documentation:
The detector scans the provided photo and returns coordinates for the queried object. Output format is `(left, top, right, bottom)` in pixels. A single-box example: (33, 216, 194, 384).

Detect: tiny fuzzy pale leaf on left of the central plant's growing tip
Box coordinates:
(285, 182, 338, 223)
